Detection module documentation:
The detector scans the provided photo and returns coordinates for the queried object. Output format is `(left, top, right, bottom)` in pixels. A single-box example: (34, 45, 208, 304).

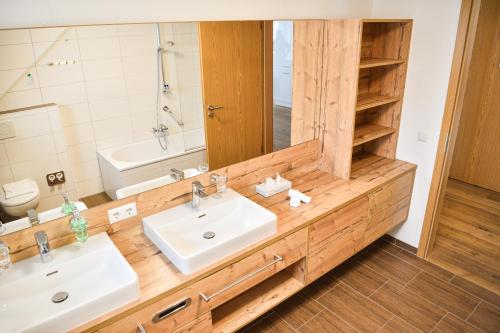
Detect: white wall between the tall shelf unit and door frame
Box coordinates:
(372, 0, 461, 247)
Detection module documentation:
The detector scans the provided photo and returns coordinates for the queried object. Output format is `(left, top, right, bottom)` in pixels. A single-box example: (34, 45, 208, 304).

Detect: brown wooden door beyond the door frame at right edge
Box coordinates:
(450, 0, 500, 192)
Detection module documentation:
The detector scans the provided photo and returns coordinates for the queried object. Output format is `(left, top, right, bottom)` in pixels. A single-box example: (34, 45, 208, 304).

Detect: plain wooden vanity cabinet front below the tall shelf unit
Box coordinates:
(308, 171, 415, 283)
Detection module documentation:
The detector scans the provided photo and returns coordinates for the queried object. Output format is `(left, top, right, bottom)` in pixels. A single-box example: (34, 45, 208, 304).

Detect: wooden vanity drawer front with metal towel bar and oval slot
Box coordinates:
(99, 228, 307, 333)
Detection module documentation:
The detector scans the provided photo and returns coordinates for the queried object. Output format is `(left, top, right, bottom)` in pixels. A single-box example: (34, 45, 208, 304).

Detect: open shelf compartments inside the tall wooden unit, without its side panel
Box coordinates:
(351, 20, 411, 163)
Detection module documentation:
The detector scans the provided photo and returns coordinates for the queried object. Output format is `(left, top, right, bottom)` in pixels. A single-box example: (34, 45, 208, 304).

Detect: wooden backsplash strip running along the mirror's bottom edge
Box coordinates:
(0, 140, 320, 262)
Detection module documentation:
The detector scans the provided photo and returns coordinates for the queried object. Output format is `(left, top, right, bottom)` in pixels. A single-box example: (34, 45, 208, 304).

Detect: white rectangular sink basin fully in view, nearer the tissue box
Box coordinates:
(142, 189, 276, 274)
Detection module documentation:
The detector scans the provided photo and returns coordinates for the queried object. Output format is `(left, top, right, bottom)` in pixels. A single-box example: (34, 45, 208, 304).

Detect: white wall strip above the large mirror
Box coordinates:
(0, 0, 372, 29)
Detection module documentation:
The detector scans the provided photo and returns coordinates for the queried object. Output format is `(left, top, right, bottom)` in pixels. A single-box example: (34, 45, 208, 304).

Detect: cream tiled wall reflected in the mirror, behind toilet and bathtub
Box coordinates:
(0, 23, 204, 226)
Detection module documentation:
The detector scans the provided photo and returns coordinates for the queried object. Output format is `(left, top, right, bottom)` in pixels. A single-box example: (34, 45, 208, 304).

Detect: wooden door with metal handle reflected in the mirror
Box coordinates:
(200, 21, 264, 170)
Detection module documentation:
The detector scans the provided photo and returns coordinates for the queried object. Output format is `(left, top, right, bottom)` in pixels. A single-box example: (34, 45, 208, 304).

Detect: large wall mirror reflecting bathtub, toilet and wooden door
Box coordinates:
(0, 21, 293, 234)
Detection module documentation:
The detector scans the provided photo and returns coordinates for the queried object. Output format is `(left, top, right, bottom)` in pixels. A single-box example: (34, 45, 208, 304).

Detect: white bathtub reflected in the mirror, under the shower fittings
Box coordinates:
(97, 130, 205, 200)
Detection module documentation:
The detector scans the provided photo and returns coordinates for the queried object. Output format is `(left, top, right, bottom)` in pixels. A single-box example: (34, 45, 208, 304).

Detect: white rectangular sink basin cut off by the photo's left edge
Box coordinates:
(0, 233, 140, 333)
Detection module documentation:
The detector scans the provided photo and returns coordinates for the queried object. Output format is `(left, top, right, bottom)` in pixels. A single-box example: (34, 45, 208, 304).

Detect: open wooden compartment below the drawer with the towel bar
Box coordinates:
(212, 271, 304, 333)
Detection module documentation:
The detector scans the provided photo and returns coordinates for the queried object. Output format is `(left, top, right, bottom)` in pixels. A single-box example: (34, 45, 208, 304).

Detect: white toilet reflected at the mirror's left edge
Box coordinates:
(0, 179, 40, 217)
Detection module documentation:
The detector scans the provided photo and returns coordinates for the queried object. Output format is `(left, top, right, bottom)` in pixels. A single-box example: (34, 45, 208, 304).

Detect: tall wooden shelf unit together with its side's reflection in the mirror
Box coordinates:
(292, 19, 412, 179)
